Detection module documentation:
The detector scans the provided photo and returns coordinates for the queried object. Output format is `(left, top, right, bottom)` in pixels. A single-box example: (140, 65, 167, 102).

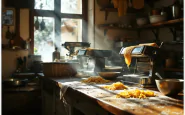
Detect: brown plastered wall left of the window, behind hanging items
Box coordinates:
(1, 0, 29, 79)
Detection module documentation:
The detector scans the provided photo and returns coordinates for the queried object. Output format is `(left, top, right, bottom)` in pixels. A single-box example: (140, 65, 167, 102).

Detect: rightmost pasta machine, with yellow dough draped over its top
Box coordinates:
(120, 45, 163, 87)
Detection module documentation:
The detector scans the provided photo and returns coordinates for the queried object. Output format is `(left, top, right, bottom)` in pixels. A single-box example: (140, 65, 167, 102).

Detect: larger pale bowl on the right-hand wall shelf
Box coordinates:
(149, 15, 166, 24)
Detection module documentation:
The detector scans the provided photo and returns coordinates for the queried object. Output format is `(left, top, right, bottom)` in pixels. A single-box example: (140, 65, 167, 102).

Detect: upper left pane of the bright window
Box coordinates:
(34, 0, 54, 10)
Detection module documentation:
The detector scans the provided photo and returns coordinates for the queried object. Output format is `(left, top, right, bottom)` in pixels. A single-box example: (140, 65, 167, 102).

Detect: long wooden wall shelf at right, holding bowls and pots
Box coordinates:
(98, 18, 184, 31)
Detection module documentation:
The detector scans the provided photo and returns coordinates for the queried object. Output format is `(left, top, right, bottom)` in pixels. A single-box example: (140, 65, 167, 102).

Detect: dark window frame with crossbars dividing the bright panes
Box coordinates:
(29, 0, 88, 54)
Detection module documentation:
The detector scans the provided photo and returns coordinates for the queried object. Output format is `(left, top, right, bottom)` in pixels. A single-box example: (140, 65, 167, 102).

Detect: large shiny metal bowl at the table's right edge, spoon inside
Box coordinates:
(155, 79, 184, 95)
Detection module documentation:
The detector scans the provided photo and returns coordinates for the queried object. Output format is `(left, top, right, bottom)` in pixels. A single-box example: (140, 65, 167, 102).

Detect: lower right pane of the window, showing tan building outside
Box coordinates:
(60, 18, 82, 56)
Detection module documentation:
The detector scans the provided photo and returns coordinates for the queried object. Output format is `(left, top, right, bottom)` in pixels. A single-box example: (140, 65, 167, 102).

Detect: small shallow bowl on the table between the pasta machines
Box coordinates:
(98, 72, 121, 79)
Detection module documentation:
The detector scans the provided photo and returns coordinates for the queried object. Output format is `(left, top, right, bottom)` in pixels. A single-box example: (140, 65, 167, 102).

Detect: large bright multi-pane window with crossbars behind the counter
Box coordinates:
(33, 0, 87, 62)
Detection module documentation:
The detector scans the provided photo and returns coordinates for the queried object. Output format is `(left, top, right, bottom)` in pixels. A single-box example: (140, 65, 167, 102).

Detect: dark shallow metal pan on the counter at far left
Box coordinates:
(2, 78, 28, 87)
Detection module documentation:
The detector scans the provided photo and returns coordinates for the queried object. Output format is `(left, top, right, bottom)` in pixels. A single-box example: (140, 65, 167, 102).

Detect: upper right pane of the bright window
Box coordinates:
(61, 0, 82, 14)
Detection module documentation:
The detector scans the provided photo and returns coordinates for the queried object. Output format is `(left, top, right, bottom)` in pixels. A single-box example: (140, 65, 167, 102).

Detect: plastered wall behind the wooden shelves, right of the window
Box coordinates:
(94, 0, 181, 49)
